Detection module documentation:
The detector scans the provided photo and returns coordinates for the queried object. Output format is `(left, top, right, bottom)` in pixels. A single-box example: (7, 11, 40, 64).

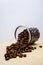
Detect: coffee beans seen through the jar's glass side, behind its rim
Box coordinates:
(29, 28, 40, 44)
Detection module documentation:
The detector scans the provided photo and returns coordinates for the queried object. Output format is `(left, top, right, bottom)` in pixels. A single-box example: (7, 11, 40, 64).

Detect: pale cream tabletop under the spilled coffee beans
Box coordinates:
(0, 41, 43, 65)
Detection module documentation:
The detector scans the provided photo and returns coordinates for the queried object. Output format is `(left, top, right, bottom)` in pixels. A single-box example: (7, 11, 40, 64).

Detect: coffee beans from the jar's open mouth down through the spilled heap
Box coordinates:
(4, 29, 40, 60)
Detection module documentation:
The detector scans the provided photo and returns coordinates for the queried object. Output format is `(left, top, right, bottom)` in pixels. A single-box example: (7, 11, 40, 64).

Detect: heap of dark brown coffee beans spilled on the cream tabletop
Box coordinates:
(4, 42, 36, 60)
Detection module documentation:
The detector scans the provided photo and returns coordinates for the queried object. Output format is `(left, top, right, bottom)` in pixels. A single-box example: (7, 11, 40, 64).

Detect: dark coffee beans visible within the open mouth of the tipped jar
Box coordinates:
(17, 29, 29, 44)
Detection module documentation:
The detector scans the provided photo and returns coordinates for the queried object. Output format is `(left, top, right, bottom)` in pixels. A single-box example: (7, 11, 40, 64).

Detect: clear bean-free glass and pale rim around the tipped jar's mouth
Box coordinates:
(14, 25, 31, 42)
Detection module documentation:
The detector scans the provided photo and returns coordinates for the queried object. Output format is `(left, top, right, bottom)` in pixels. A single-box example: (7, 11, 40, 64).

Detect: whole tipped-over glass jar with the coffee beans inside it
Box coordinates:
(15, 26, 40, 44)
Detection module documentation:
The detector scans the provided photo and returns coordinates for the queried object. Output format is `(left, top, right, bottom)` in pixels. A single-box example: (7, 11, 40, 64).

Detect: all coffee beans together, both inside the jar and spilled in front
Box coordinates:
(4, 25, 40, 60)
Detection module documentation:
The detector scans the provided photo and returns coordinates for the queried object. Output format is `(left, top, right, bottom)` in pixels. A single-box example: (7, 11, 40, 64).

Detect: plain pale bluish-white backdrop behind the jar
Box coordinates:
(0, 0, 43, 41)
